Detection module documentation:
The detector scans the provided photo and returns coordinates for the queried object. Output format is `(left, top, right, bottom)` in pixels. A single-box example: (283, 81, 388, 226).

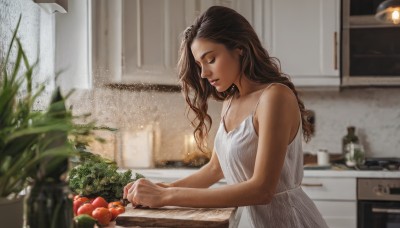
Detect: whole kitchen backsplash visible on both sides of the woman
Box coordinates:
(70, 88, 400, 165)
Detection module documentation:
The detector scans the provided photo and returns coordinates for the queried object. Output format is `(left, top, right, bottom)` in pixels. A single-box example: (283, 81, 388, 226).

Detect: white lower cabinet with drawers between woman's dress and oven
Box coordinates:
(302, 177, 357, 228)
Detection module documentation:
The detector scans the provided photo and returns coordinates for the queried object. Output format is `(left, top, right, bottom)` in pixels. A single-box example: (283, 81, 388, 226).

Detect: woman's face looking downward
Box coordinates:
(191, 38, 241, 92)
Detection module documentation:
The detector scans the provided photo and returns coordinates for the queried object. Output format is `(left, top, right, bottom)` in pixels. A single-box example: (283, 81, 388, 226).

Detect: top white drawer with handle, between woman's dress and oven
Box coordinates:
(301, 177, 356, 200)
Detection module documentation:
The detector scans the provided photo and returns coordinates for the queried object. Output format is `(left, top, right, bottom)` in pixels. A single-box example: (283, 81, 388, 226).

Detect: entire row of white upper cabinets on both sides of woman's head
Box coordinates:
(92, 0, 340, 86)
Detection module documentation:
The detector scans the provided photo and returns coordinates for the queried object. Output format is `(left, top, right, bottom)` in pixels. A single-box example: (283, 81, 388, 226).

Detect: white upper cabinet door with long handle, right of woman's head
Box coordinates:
(263, 0, 339, 86)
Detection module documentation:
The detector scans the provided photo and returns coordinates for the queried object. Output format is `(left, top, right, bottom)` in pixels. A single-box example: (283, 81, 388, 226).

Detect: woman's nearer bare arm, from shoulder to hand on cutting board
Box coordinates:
(128, 85, 300, 207)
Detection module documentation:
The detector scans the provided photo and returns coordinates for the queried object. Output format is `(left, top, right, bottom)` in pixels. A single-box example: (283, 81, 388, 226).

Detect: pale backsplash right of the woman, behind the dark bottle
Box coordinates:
(302, 88, 400, 157)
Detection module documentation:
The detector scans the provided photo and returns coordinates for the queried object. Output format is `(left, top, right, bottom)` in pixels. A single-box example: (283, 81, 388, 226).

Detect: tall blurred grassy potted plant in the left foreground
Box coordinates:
(0, 17, 98, 228)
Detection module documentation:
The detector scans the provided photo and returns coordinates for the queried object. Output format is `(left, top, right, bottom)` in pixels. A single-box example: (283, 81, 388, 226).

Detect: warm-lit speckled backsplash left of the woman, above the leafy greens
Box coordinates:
(69, 89, 220, 166)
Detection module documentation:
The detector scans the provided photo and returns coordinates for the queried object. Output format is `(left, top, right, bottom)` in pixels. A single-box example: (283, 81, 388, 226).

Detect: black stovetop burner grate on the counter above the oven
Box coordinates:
(358, 157, 400, 171)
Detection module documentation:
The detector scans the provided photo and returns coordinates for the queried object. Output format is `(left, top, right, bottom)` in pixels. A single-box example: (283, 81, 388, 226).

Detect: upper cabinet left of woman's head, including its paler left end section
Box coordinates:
(93, 0, 256, 85)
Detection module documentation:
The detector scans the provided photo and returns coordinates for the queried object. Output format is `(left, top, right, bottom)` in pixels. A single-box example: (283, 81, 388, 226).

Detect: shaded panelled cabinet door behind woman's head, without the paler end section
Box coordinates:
(122, 0, 253, 84)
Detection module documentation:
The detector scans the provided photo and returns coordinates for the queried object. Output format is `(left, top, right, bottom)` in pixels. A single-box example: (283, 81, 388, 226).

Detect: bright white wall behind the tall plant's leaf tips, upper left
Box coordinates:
(0, 0, 55, 109)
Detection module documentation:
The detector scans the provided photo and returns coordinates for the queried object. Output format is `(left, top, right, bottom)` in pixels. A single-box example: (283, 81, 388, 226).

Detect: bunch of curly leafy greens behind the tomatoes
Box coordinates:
(69, 152, 143, 202)
